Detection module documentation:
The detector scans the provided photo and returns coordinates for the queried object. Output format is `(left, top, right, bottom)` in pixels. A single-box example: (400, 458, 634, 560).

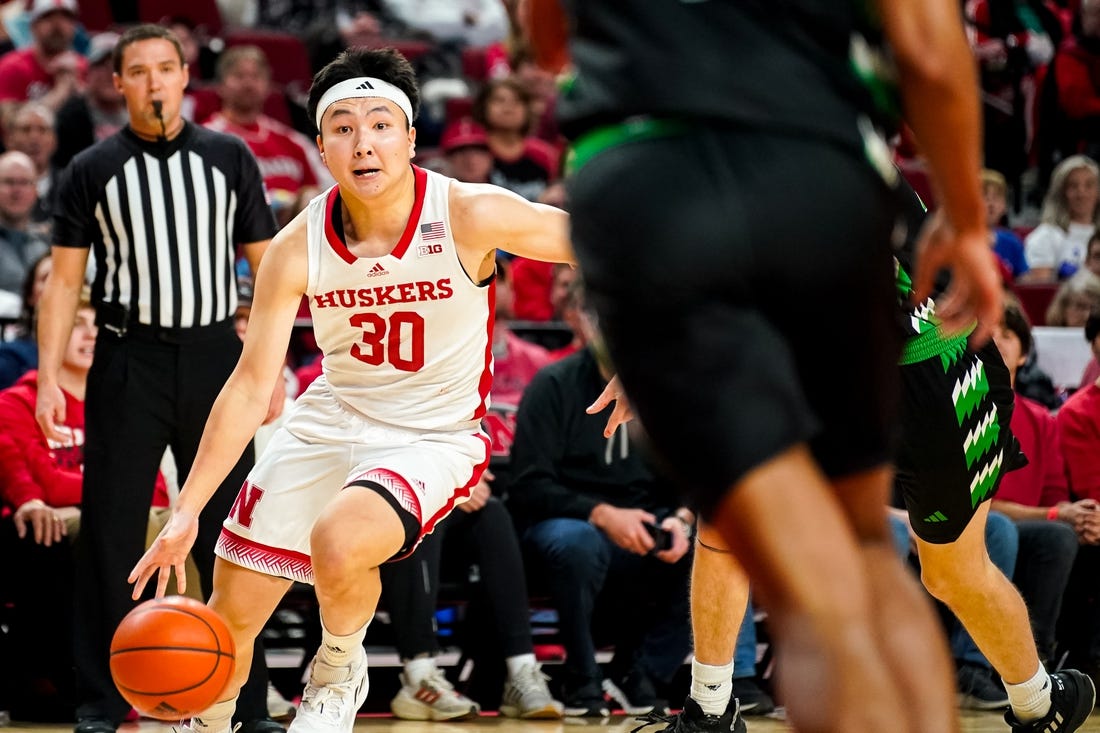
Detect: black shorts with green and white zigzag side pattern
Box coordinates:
(895, 334, 1026, 544)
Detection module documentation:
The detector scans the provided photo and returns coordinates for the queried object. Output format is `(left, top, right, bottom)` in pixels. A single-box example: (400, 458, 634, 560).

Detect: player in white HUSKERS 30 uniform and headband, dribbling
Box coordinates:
(130, 50, 573, 733)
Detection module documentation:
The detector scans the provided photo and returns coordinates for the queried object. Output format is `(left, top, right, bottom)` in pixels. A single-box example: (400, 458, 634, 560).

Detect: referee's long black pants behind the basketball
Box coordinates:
(75, 320, 267, 725)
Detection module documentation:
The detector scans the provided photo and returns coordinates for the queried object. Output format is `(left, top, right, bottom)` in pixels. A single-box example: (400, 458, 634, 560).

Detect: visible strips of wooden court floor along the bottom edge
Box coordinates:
(0, 712, 1100, 733)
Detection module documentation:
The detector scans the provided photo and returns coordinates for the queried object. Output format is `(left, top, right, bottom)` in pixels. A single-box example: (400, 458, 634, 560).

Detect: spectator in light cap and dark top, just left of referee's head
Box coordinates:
(54, 32, 129, 168)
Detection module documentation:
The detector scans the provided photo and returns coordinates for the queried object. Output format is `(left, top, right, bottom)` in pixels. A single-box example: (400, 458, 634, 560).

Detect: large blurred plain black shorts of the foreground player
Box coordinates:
(568, 127, 900, 516)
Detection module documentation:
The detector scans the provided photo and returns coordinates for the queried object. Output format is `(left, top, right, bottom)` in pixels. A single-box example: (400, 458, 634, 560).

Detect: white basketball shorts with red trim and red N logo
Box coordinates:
(216, 378, 490, 583)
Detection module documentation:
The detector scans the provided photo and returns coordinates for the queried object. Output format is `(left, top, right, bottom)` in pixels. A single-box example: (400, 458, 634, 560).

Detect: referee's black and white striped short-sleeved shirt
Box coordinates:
(54, 123, 275, 328)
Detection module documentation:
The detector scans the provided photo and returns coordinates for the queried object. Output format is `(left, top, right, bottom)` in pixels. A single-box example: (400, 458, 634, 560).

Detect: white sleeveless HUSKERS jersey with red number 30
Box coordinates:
(306, 166, 495, 431)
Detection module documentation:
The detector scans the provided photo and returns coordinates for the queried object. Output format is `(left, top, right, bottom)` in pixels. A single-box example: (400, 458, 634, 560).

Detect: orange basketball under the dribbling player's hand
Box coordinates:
(111, 595, 235, 720)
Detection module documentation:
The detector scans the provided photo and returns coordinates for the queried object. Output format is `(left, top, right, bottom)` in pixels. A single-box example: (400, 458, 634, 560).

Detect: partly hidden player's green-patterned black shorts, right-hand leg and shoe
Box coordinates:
(894, 181, 1096, 731)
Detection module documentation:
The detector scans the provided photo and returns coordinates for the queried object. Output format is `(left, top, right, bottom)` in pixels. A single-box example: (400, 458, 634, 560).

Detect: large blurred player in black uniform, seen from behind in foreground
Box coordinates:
(514, 0, 1073, 733)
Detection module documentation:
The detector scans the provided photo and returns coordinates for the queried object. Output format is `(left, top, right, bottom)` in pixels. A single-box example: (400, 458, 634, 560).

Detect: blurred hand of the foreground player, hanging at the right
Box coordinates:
(913, 211, 1003, 348)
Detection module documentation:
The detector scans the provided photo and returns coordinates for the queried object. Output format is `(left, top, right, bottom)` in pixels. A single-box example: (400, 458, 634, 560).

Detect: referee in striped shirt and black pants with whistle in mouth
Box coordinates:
(37, 25, 282, 733)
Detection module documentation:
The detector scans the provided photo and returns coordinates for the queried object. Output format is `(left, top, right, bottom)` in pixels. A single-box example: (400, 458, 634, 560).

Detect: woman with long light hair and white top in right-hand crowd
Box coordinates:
(1024, 155, 1100, 282)
